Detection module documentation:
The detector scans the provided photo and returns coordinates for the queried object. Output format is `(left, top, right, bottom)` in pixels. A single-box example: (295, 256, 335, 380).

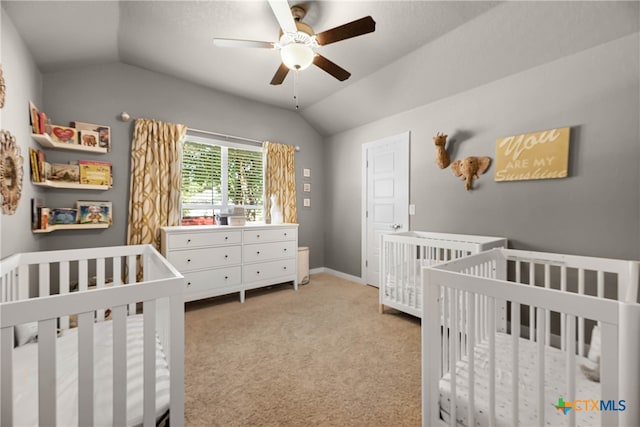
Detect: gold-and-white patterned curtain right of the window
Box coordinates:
(262, 142, 298, 224)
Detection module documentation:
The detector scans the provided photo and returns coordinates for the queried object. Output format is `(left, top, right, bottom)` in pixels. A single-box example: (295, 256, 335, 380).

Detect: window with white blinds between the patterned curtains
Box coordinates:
(181, 135, 264, 225)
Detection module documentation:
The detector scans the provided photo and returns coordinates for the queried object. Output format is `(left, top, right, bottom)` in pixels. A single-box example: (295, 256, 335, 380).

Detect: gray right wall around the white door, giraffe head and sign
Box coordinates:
(325, 33, 640, 276)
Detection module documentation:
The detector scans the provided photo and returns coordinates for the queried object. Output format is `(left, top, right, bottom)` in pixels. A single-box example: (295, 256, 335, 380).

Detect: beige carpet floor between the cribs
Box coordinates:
(185, 274, 421, 427)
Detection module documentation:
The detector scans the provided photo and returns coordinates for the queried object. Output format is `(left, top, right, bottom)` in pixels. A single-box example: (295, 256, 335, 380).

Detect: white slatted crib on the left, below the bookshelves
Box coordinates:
(0, 245, 184, 426)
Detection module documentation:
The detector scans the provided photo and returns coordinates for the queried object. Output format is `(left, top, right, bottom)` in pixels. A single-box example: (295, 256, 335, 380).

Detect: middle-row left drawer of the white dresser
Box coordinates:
(167, 245, 242, 272)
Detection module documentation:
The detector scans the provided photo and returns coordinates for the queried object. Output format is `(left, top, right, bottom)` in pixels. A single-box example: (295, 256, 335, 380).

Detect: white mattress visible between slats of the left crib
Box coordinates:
(13, 315, 169, 426)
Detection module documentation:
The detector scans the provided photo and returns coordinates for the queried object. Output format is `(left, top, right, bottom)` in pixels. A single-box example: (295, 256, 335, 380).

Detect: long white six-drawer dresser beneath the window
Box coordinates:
(160, 224, 298, 302)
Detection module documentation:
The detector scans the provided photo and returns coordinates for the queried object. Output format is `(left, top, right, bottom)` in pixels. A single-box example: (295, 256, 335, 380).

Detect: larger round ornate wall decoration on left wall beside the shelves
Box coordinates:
(0, 129, 23, 215)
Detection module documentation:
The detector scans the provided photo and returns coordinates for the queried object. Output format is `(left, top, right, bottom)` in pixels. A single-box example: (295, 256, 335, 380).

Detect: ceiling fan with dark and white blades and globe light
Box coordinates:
(213, 0, 376, 85)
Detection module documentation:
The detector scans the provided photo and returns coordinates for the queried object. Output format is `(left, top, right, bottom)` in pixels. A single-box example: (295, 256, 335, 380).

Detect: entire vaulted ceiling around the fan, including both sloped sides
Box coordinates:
(2, 0, 640, 135)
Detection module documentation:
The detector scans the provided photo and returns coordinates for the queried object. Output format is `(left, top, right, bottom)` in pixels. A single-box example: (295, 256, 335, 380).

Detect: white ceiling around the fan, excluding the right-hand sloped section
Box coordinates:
(3, 1, 496, 108)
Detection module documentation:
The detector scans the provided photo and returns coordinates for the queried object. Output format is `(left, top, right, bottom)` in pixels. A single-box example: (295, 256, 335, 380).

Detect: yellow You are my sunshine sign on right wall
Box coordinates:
(494, 128, 571, 181)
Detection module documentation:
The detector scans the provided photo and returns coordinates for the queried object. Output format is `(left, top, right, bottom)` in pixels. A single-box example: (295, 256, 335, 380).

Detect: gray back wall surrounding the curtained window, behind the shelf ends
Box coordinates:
(43, 63, 324, 268)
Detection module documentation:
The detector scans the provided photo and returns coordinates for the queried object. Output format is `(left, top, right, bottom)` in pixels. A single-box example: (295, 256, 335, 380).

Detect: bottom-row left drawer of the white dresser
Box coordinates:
(184, 265, 242, 301)
